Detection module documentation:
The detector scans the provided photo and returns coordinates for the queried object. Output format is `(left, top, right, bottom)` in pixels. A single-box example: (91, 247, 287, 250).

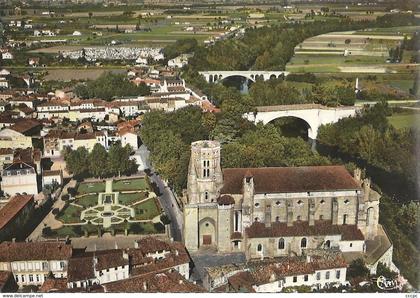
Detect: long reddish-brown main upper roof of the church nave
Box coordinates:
(221, 166, 360, 194)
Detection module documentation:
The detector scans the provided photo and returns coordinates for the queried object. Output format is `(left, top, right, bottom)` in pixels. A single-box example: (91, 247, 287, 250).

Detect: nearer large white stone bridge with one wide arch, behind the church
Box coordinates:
(244, 104, 361, 140)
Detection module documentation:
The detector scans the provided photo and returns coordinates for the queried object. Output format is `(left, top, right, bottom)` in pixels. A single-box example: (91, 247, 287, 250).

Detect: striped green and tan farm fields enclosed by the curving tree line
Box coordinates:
(286, 26, 419, 74)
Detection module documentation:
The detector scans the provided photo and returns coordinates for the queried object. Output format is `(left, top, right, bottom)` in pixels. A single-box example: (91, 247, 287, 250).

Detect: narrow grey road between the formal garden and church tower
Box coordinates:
(150, 172, 184, 241)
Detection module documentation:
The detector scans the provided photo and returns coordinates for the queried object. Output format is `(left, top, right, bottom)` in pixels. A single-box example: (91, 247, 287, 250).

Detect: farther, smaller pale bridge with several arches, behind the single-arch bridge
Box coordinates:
(199, 70, 289, 83)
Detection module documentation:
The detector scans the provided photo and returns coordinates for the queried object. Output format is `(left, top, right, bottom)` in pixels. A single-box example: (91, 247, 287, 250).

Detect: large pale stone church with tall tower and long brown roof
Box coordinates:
(183, 140, 398, 272)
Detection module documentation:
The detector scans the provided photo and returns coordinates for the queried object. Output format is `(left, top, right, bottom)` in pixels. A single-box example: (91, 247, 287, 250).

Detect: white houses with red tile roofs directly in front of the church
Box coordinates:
(203, 250, 348, 293)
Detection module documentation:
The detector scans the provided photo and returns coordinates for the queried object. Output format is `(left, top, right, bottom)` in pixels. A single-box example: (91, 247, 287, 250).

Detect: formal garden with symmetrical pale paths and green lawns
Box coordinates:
(43, 177, 166, 238)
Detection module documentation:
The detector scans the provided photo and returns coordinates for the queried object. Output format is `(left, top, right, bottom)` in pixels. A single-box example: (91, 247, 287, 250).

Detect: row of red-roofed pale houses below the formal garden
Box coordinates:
(0, 237, 191, 292)
